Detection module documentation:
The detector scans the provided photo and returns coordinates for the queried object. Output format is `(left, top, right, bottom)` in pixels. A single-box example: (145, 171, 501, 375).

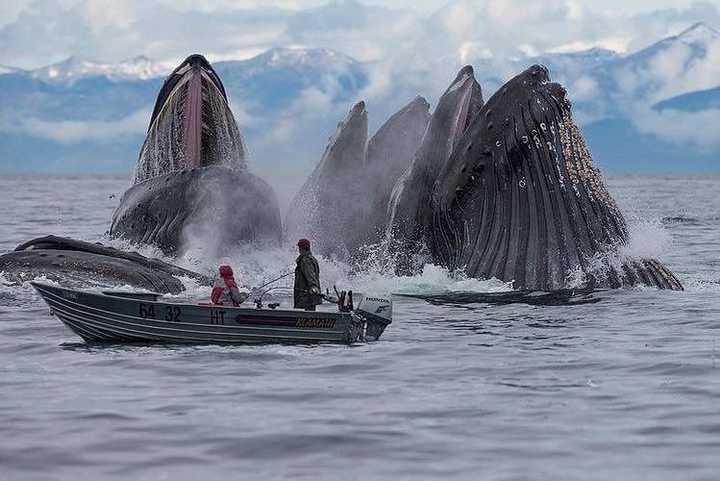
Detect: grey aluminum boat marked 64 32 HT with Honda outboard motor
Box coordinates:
(31, 282, 392, 344)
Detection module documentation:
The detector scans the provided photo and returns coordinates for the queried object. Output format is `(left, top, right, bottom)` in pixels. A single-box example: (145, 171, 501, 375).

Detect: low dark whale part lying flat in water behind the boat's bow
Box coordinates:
(0, 236, 211, 294)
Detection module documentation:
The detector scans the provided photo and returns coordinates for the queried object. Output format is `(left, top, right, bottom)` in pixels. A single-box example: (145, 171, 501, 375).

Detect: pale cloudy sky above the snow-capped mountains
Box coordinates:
(0, 0, 720, 68)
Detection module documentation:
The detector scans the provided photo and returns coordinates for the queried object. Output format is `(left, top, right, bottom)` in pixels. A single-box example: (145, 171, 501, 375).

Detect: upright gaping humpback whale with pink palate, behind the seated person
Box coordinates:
(110, 55, 281, 255)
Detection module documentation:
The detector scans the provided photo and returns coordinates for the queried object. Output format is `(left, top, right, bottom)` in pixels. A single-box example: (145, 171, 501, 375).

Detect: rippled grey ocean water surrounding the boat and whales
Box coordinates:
(0, 176, 720, 481)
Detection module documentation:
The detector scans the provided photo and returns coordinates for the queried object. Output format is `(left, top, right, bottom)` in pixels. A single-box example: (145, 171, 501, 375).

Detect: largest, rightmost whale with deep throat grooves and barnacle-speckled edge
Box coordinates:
(424, 65, 682, 291)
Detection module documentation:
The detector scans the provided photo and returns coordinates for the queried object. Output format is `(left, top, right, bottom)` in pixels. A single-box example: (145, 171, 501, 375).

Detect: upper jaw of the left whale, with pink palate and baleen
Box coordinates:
(135, 55, 246, 183)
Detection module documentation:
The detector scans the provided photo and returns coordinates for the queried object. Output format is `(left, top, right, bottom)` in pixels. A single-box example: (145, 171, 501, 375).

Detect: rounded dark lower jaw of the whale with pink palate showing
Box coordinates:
(110, 166, 281, 255)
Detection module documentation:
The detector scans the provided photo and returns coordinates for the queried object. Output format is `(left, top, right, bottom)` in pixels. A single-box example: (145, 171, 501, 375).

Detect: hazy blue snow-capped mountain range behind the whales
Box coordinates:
(0, 24, 720, 195)
